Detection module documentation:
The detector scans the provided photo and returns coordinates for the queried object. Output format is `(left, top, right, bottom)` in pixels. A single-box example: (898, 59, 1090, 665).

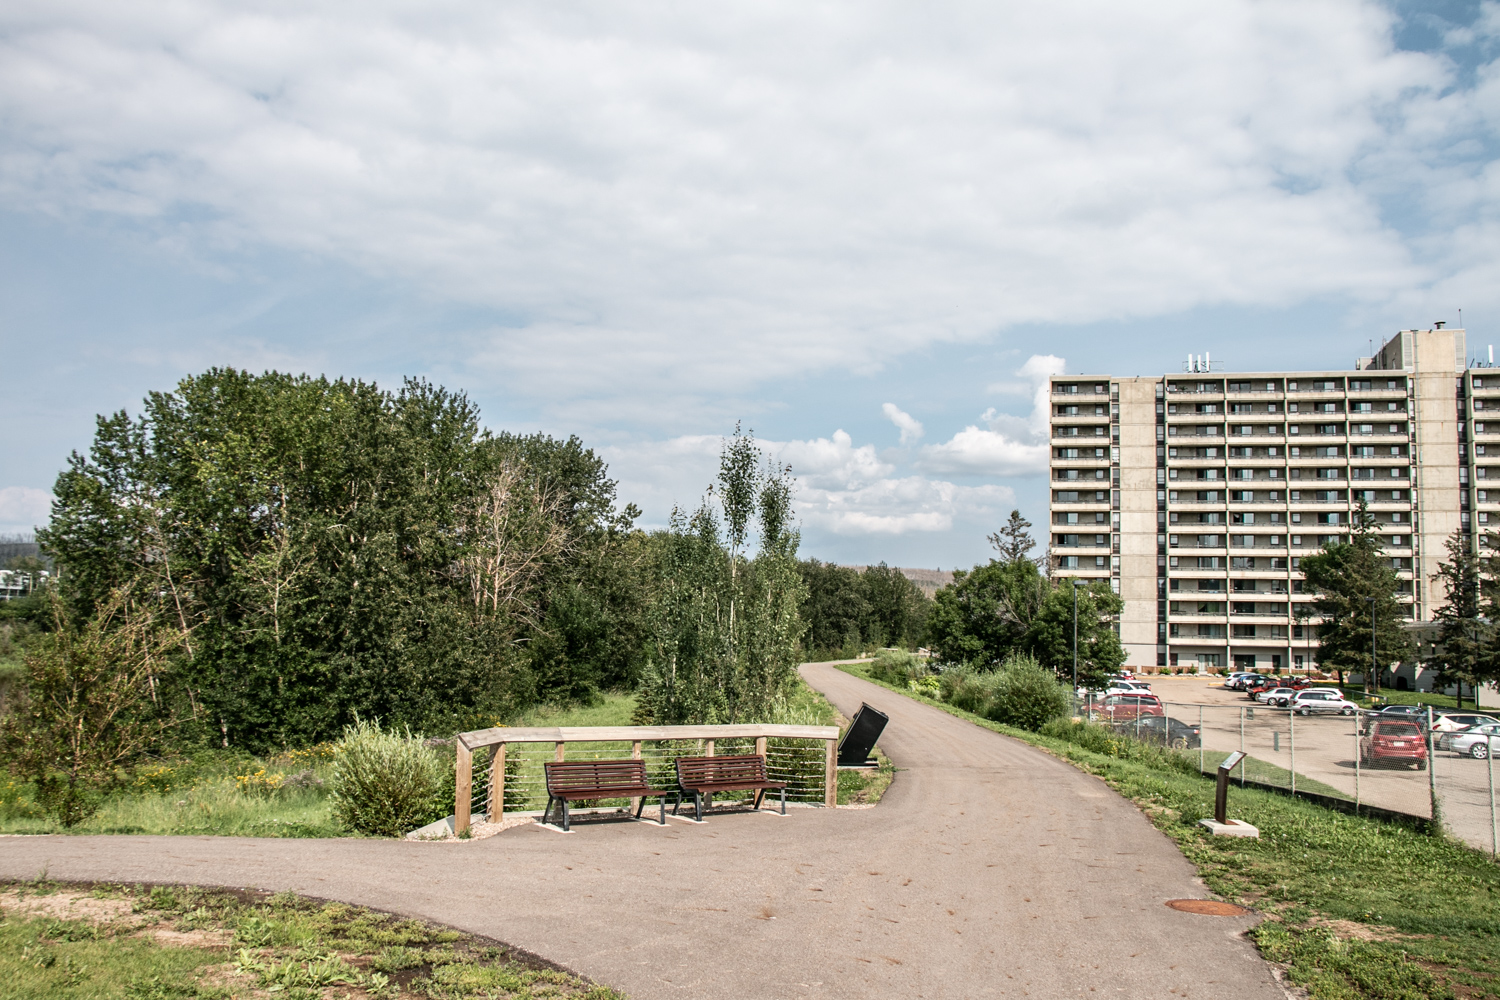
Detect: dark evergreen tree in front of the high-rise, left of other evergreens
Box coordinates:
(1302, 499, 1416, 693)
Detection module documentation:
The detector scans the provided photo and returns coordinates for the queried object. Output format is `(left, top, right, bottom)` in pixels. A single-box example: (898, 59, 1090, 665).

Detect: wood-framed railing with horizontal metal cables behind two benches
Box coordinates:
(453, 723, 839, 834)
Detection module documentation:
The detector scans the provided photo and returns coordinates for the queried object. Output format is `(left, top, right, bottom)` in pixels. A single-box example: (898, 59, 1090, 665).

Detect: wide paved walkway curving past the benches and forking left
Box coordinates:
(0, 664, 1286, 1000)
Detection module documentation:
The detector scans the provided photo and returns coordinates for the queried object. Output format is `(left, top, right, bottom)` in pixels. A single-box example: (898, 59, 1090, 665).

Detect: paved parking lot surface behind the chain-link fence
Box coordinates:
(1145, 676, 1494, 850)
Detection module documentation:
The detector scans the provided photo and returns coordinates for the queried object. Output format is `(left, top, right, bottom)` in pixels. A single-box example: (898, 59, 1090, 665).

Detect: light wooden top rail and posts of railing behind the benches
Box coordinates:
(453, 723, 839, 834)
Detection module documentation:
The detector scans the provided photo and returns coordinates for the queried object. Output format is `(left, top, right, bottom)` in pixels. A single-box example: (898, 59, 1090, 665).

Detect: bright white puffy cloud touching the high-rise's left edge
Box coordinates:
(920, 354, 1067, 475)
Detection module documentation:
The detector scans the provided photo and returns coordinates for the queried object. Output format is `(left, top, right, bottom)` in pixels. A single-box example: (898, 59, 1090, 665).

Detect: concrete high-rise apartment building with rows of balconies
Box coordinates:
(1049, 325, 1500, 669)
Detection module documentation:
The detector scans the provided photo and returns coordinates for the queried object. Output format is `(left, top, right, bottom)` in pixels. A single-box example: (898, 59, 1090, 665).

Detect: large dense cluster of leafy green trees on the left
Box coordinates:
(39, 369, 642, 750)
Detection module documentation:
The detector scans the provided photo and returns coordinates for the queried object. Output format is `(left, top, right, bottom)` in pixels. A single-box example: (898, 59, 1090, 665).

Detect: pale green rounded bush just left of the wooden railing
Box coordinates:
(333, 721, 453, 837)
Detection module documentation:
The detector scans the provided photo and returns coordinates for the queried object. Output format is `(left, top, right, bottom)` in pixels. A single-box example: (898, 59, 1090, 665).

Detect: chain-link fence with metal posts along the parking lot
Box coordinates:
(1080, 700, 1500, 853)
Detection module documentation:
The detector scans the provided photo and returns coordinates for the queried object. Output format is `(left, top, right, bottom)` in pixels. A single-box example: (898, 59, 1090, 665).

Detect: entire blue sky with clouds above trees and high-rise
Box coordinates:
(0, 0, 1500, 568)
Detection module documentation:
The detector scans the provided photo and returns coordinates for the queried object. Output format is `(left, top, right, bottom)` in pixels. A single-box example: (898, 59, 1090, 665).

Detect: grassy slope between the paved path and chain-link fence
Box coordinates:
(843, 664, 1500, 1000)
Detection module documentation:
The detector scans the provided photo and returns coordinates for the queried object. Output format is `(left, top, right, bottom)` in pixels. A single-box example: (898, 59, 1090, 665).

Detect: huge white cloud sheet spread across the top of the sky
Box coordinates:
(0, 0, 1496, 426)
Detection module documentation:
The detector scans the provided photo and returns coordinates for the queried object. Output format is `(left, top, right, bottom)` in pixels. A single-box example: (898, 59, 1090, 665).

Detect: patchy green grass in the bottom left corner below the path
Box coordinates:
(0, 882, 621, 1000)
